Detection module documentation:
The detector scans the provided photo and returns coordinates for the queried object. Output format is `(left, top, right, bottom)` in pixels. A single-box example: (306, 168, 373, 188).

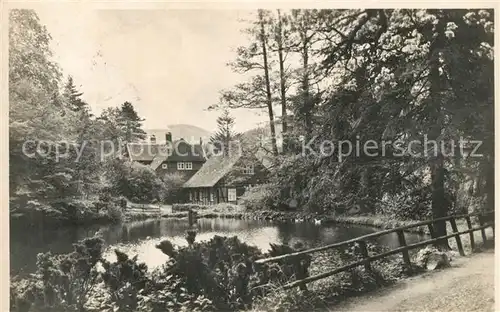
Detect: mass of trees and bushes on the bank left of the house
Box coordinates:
(9, 10, 175, 222)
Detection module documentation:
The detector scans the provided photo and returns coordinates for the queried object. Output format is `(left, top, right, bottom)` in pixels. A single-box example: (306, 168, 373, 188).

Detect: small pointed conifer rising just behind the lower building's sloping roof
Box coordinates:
(210, 108, 241, 156)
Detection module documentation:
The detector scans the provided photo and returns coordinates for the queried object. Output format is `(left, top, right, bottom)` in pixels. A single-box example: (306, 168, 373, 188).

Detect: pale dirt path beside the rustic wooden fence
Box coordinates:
(332, 250, 495, 312)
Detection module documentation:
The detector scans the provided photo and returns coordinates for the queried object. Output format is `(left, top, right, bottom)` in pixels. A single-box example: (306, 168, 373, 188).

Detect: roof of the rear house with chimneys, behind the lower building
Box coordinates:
(127, 139, 205, 163)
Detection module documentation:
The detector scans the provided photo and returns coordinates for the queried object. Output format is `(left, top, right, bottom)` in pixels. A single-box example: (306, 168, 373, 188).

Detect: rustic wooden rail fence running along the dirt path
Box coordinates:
(255, 211, 495, 289)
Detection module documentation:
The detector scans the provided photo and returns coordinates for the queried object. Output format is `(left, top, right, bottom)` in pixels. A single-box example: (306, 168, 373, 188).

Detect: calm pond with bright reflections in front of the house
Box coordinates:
(10, 219, 426, 275)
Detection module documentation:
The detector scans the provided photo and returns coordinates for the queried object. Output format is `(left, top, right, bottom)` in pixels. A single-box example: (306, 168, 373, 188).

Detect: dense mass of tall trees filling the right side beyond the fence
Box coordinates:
(221, 9, 494, 234)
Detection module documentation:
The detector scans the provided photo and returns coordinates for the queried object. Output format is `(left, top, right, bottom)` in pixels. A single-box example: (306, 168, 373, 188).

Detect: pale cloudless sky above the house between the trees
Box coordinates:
(36, 4, 266, 132)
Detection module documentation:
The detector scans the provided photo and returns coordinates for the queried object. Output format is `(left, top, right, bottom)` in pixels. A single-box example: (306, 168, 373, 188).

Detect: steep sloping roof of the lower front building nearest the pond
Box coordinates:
(183, 153, 241, 188)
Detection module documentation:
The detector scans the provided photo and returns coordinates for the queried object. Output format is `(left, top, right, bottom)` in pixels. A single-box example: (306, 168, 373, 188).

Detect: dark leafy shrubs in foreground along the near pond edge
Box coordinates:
(11, 231, 403, 312)
